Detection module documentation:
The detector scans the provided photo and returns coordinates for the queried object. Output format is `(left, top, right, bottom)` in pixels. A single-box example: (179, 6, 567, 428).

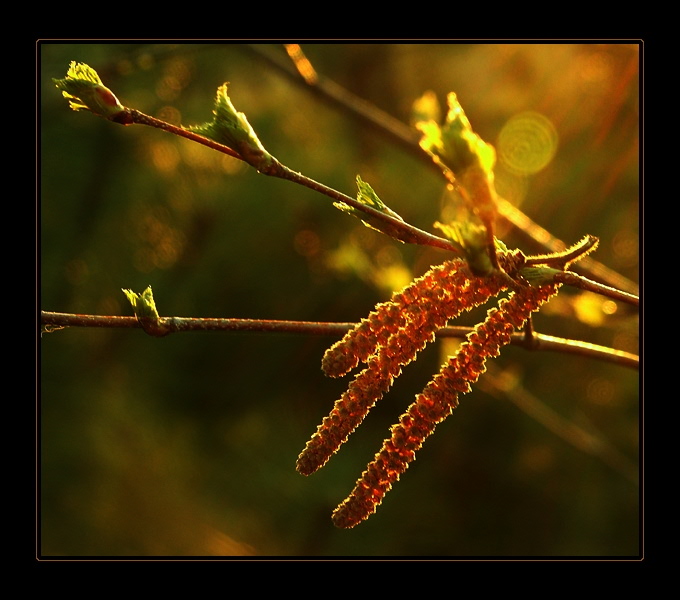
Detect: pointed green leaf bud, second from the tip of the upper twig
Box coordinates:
(188, 83, 275, 171)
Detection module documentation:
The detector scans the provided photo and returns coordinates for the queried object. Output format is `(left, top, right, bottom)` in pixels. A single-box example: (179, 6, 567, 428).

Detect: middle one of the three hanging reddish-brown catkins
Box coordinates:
(296, 261, 505, 475)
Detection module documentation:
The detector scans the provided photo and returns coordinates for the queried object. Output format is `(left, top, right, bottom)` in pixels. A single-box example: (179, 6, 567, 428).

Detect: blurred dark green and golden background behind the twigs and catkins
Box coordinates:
(38, 43, 640, 557)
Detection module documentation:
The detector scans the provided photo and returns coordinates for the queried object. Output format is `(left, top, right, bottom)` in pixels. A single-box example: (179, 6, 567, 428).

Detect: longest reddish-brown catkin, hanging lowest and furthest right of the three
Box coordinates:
(333, 285, 558, 528)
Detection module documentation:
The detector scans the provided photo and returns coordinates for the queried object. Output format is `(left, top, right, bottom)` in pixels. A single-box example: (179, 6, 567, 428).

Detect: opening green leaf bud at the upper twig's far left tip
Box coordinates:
(52, 61, 125, 119)
